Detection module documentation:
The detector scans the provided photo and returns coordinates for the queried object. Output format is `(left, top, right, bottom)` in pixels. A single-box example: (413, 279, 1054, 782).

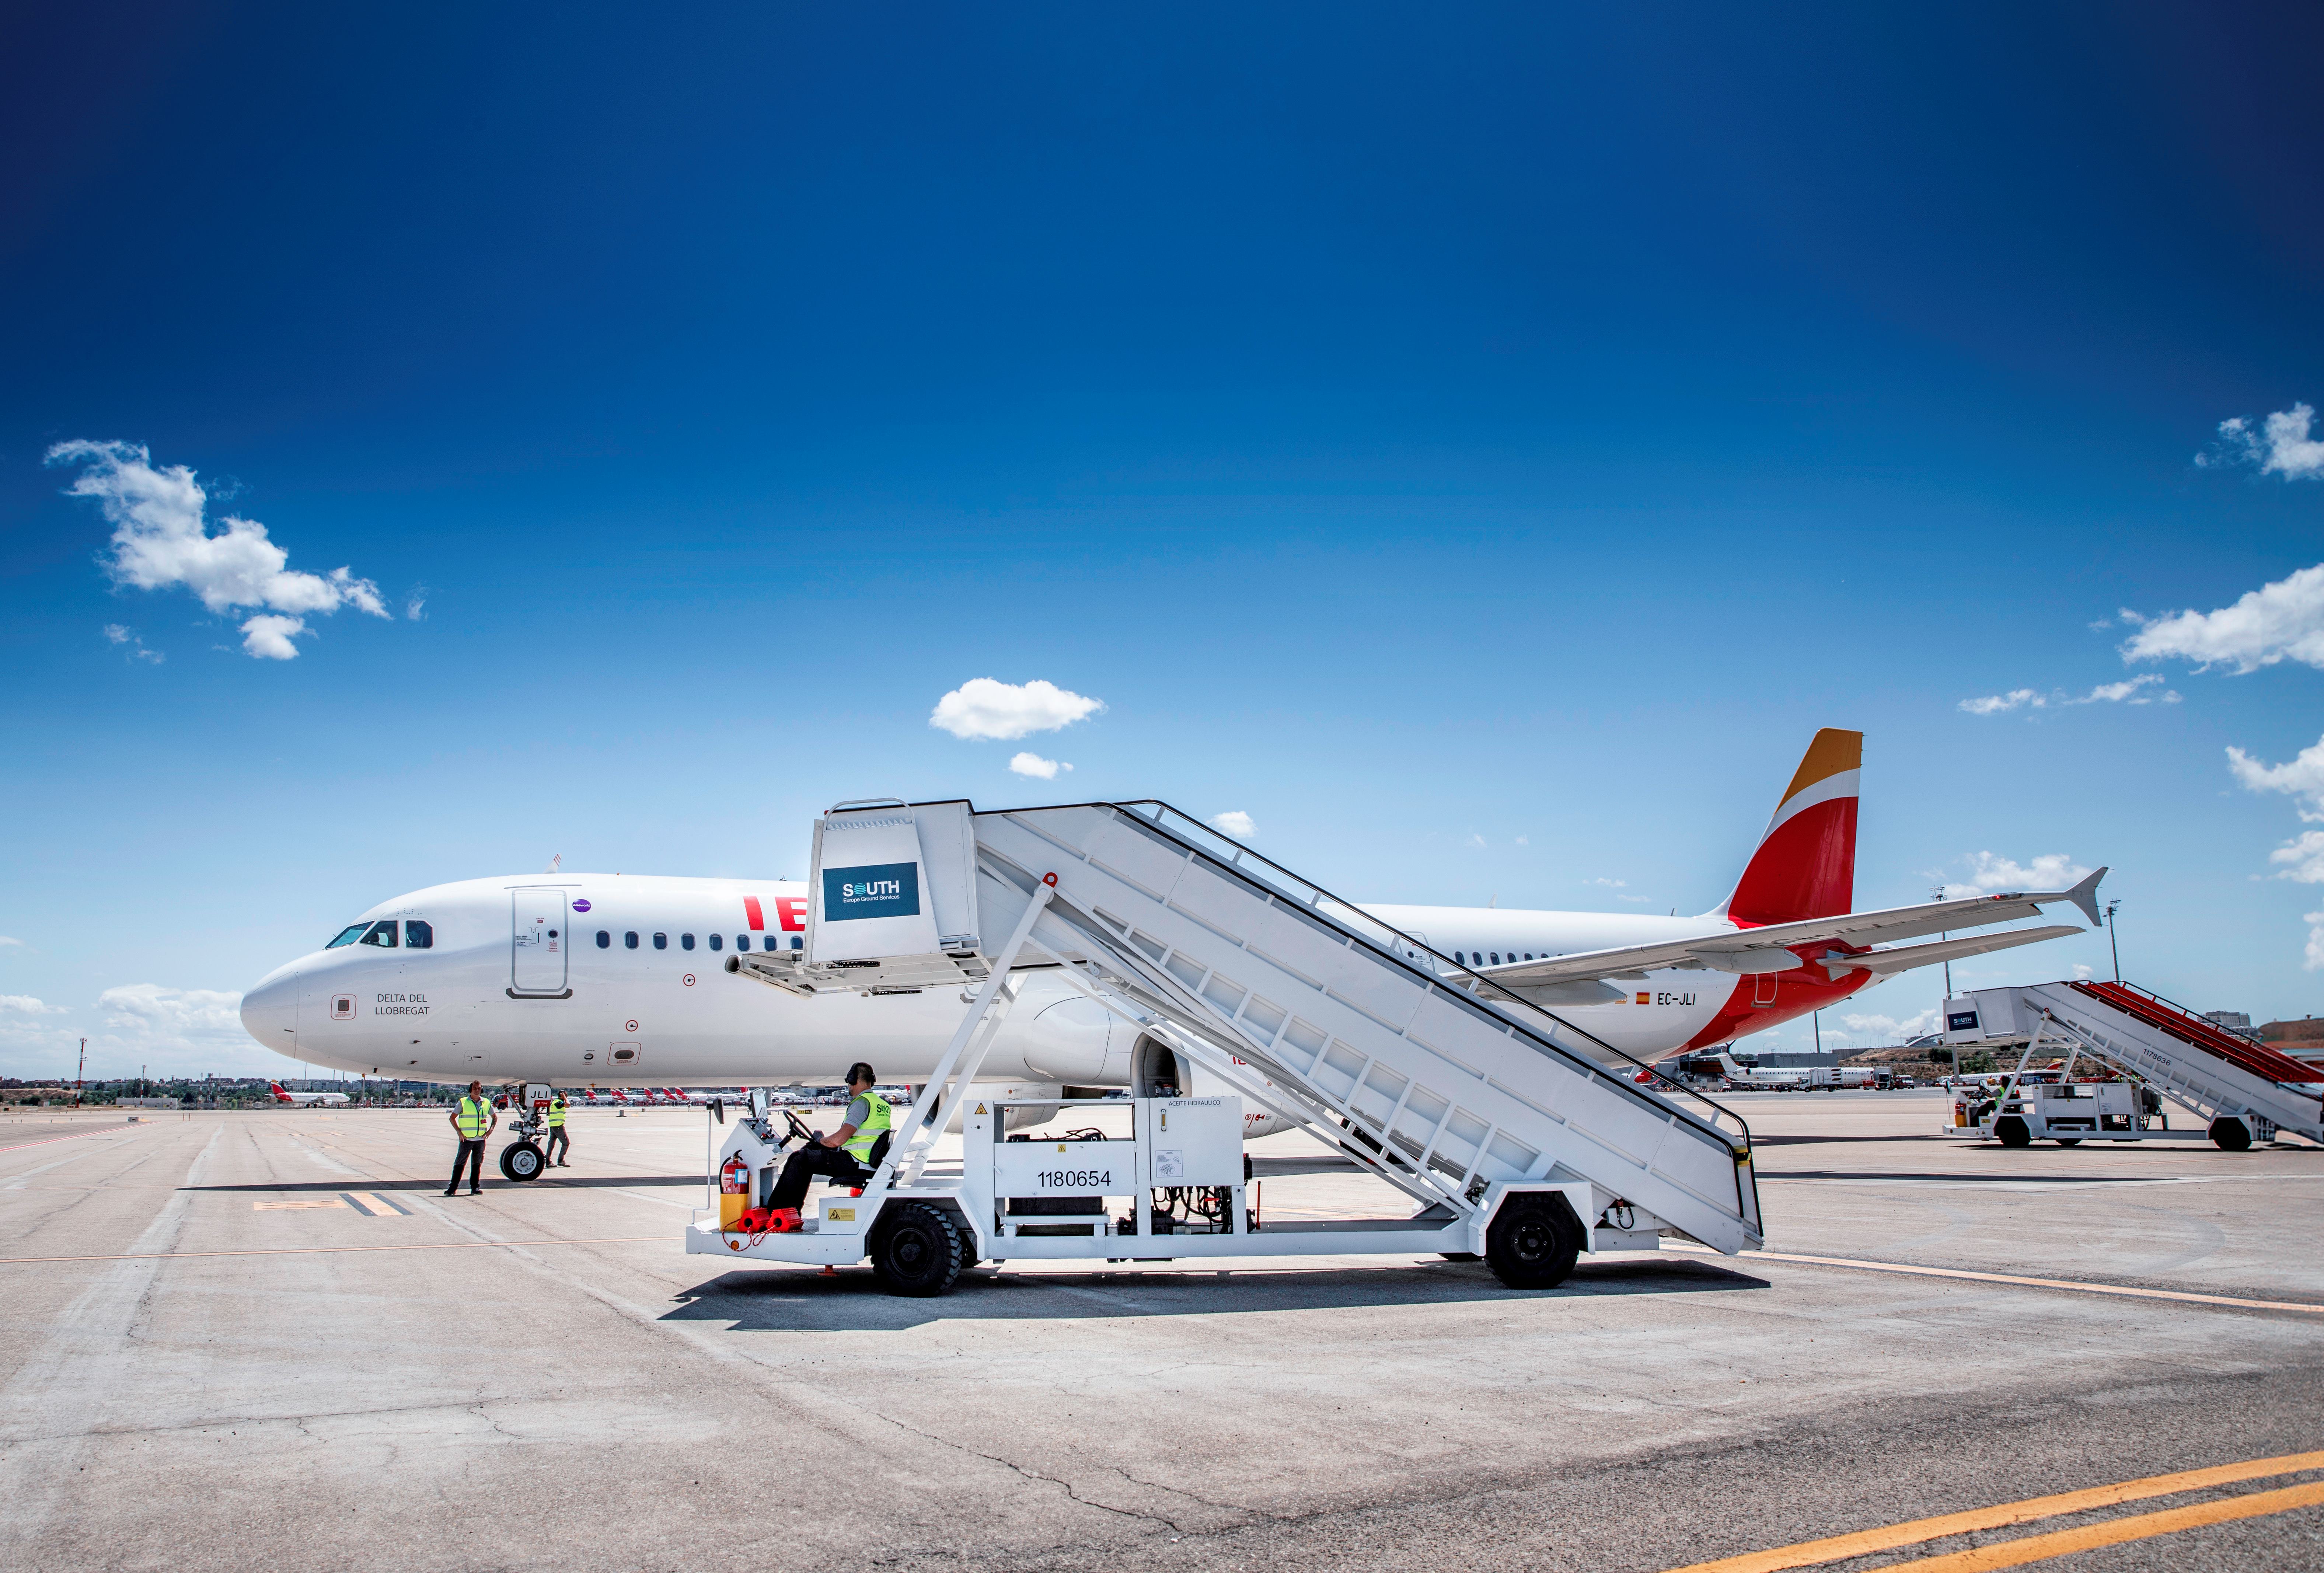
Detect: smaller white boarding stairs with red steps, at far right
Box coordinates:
(1945, 980, 2324, 1152)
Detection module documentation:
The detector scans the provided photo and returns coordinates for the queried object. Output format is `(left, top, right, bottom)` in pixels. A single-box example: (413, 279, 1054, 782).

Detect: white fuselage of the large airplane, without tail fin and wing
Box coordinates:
(242, 873, 1864, 1087)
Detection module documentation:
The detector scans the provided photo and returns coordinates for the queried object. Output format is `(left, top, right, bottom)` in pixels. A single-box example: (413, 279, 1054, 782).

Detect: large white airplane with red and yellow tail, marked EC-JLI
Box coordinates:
(242, 730, 2105, 1136)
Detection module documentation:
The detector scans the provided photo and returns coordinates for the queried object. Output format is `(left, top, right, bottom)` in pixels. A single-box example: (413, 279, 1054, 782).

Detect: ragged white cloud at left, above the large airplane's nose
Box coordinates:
(49, 442, 388, 660)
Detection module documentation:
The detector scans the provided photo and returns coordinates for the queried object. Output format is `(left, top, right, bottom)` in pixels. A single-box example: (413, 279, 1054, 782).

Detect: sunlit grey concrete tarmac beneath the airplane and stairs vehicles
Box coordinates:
(0, 1094, 2324, 1573)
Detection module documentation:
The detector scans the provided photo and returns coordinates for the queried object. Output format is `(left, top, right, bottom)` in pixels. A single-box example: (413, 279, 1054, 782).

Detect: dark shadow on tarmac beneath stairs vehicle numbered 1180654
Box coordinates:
(662, 1259, 1771, 1334)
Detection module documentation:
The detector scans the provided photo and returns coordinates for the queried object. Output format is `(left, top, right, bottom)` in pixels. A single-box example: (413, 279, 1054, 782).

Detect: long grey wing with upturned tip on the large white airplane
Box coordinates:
(1476, 869, 2105, 990)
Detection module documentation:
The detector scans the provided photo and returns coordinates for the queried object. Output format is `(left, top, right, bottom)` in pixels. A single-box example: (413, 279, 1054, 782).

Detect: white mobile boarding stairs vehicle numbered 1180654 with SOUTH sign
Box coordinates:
(685, 799, 1762, 1294)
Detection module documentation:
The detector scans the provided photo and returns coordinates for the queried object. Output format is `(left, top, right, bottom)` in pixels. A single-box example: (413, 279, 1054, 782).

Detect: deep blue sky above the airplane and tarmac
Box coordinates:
(0, 5, 2324, 1076)
